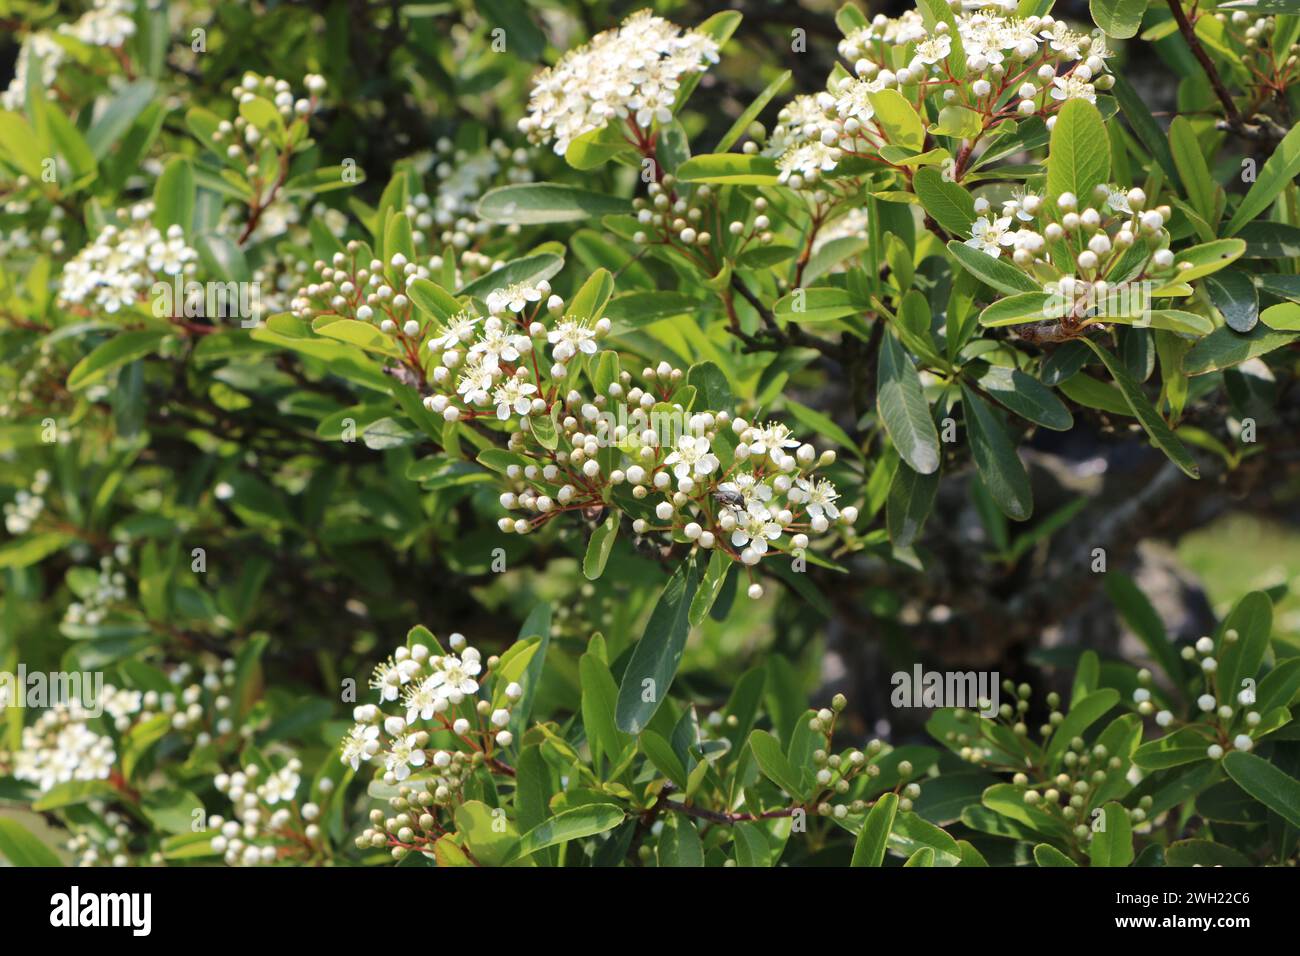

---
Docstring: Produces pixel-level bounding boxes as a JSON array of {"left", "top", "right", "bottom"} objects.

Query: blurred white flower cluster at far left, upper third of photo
[{"left": 59, "top": 202, "right": 199, "bottom": 315}]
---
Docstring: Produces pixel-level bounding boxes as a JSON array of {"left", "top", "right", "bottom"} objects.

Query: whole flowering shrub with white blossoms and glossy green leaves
[{"left": 0, "top": 0, "right": 1300, "bottom": 866}]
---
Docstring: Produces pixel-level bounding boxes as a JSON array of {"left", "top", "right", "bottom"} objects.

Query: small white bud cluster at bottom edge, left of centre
[{"left": 207, "top": 757, "right": 333, "bottom": 866}]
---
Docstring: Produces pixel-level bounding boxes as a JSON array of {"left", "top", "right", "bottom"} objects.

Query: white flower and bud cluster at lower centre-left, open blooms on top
[{"left": 339, "top": 633, "right": 524, "bottom": 860}]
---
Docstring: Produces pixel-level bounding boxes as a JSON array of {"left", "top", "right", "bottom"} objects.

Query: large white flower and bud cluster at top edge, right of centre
[{"left": 766, "top": 6, "right": 1114, "bottom": 189}]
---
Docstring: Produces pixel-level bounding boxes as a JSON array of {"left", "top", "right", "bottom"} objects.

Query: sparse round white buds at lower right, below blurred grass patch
[{"left": 1134, "top": 628, "right": 1262, "bottom": 760}]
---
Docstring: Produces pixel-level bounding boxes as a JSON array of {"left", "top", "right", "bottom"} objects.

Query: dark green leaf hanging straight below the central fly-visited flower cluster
[{"left": 615, "top": 555, "right": 699, "bottom": 734}]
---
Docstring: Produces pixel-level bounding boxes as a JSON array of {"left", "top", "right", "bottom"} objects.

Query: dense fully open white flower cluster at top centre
[{"left": 519, "top": 10, "right": 718, "bottom": 155}]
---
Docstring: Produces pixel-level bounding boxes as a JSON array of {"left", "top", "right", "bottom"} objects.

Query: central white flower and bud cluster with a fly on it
[{"left": 498, "top": 363, "right": 858, "bottom": 598}]
